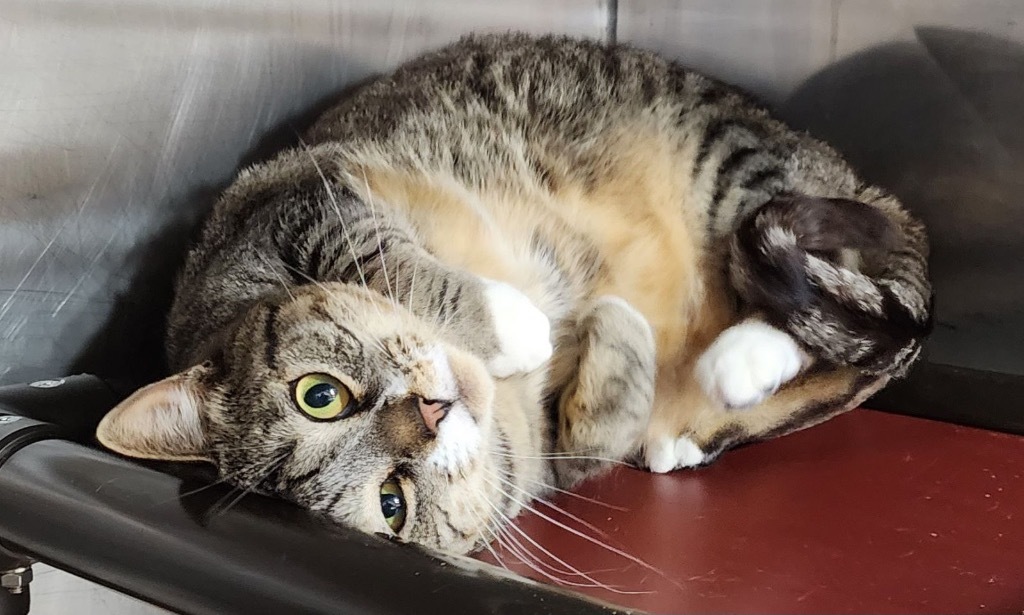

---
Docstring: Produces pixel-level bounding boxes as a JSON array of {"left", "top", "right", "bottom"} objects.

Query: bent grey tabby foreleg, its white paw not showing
[{"left": 554, "top": 296, "right": 655, "bottom": 488}]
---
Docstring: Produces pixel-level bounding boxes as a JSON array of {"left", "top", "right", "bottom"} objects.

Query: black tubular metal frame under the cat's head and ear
[{"left": 0, "top": 377, "right": 628, "bottom": 615}]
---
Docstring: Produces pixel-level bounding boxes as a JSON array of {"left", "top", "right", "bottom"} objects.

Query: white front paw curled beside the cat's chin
[{"left": 483, "top": 279, "right": 554, "bottom": 378}]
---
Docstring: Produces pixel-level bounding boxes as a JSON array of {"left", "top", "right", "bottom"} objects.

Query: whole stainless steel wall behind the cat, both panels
[{"left": 0, "top": 0, "right": 1024, "bottom": 388}]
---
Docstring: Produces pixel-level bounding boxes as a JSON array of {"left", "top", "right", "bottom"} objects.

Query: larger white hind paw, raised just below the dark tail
[{"left": 696, "top": 320, "right": 803, "bottom": 408}]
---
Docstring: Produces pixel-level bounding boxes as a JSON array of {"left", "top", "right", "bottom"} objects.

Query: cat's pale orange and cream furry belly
[{"left": 356, "top": 128, "right": 726, "bottom": 362}]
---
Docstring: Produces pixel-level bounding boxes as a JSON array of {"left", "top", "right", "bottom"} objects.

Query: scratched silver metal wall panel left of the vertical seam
[{"left": 0, "top": 0, "right": 608, "bottom": 382}]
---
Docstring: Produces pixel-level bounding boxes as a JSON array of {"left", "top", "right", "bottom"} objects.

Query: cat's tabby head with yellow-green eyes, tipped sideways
[{"left": 97, "top": 284, "right": 510, "bottom": 553}]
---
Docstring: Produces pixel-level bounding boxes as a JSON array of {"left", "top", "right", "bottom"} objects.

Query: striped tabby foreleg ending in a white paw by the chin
[{"left": 288, "top": 193, "right": 553, "bottom": 378}]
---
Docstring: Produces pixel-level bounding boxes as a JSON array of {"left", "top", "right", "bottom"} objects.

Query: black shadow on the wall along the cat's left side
[{"left": 72, "top": 78, "right": 382, "bottom": 388}]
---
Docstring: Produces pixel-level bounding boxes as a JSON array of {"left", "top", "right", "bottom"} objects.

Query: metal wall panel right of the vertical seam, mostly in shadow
[{"left": 617, "top": 0, "right": 1024, "bottom": 375}]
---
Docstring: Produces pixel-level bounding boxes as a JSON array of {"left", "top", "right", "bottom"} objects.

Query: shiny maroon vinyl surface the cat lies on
[{"left": 484, "top": 410, "right": 1024, "bottom": 613}]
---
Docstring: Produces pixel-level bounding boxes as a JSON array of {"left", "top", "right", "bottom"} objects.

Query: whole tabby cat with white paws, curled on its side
[{"left": 96, "top": 34, "right": 932, "bottom": 554}]
